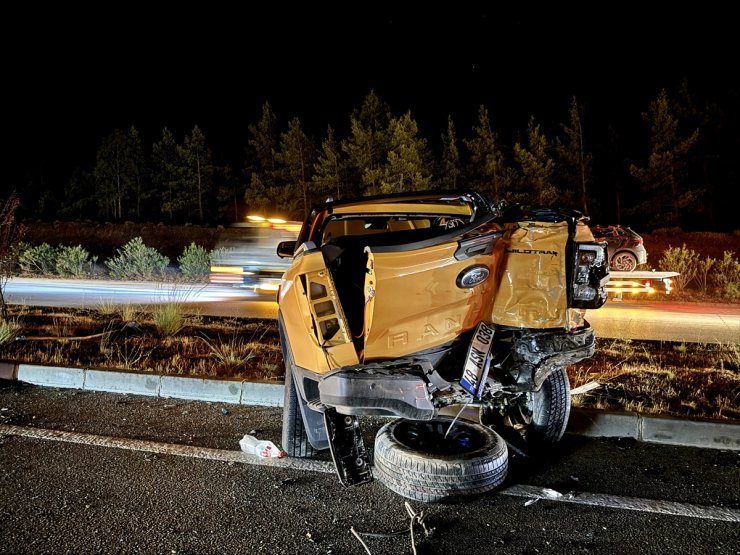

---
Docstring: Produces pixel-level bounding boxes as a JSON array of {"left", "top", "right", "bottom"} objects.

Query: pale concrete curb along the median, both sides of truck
[{"left": 0, "top": 363, "right": 740, "bottom": 451}]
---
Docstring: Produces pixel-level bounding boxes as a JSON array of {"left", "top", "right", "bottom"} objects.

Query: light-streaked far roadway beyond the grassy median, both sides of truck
[{"left": 6, "top": 278, "right": 740, "bottom": 343}]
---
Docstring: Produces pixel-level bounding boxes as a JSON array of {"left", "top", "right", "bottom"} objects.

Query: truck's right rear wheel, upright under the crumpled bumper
[{"left": 508, "top": 367, "right": 571, "bottom": 447}]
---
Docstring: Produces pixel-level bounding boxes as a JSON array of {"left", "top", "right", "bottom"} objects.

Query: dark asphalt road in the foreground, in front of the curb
[{"left": 0, "top": 382, "right": 740, "bottom": 555}]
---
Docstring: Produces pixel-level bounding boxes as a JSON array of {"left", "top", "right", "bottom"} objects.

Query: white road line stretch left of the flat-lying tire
[{"left": 0, "top": 424, "right": 335, "bottom": 474}]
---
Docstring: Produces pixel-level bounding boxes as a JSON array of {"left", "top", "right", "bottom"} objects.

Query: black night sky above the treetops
[{"left": 2, "top": 2, "right": 737, "bottom": 200}]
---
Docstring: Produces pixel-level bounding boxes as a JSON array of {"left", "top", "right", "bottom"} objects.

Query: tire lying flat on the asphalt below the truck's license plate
[{"left": 373, "top": 417, "right": 509, "bottom": 503}]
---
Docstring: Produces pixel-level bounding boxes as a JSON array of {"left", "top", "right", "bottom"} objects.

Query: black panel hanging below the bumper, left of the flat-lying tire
[{"left": 324, "top": 408, "right": 373, "bottom": 486}]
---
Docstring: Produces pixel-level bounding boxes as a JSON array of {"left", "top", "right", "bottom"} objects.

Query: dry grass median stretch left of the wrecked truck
[{"left": 0, "top": 305, "right": 283, "bottom": 379}]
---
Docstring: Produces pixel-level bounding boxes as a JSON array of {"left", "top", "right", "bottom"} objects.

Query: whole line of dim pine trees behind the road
[{"left": 46, "top": 83, "right": 737, "bottom": 231}]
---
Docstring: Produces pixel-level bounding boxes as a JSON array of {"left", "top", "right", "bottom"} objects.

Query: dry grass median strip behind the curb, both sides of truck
[{"left": 0, "top": 303, "right": 740, "bottom": 423}]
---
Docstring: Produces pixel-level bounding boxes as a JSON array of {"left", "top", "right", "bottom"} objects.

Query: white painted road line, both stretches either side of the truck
[{"left": 0, "top": 424, "right": 740, "bottom": 522}]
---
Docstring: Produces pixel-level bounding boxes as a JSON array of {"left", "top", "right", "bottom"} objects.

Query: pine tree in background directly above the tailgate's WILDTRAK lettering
[{"left": 514, "top": 116, "right": 560, "bottom": 205}]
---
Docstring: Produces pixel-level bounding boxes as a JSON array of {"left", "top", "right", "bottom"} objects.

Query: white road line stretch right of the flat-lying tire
[{"left": 499, "top": 484, "right": 740, "bottom": 522}]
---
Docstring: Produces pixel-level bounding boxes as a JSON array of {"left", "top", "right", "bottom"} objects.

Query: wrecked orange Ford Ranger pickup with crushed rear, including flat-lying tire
[{"left": 277, "top": 190, "right": 609, "bottom": 502}]
